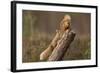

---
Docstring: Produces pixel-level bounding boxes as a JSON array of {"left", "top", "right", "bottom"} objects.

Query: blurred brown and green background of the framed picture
[{"left": 22, "top": 10, "right": 91, "bottom": 63}]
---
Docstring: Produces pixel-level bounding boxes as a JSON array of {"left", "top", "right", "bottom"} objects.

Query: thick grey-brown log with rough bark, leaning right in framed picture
[{"left": 48, "top": 31, "right": 75, "bottom": 61}]
